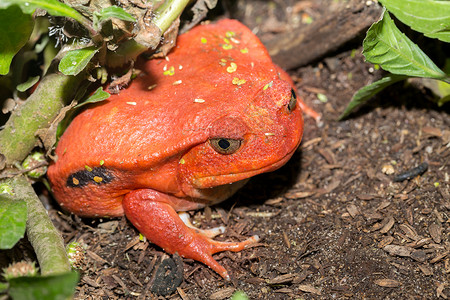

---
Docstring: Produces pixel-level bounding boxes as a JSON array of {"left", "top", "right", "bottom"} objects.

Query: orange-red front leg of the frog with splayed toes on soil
[{"left": 122, "top": 189, "right": 259, "bottom": 279}]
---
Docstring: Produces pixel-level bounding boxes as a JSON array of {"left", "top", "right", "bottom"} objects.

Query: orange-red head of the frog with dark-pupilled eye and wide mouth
[{"left": 179, "top": 80, "right": 303, "bottom": 201}]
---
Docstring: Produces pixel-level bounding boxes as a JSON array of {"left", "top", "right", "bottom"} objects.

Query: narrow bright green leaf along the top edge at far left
[{"left": 0, "top": 0, "right": 89, "bottom": 24}]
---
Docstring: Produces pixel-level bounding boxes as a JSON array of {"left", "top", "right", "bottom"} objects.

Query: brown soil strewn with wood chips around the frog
[{"left": 4, "top": 1, "right": 450, "bottom": 299}]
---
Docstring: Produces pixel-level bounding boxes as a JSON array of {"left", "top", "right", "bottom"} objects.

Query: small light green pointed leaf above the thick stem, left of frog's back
[{"left": 58, "top": 46, "right": 98, "bottom": 75}]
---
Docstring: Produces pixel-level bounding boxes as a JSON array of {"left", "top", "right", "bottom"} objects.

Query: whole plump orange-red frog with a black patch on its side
[{"left": 48, "top": 20, "right": 310, "bottom": 278}]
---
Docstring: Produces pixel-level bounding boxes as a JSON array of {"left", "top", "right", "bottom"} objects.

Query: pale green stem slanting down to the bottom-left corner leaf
[{"left": 0, "top": 175, "right": 71, "bottom": 276}]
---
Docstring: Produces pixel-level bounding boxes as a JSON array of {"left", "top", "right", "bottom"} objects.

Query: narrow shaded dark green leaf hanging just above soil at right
[{"left": 339, "top": 74, "right": 408, "bottom": 120}]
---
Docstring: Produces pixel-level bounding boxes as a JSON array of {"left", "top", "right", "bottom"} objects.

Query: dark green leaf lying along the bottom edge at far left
[{"left": 9, "top": 272, "right": 78, "bottom": 300}]
